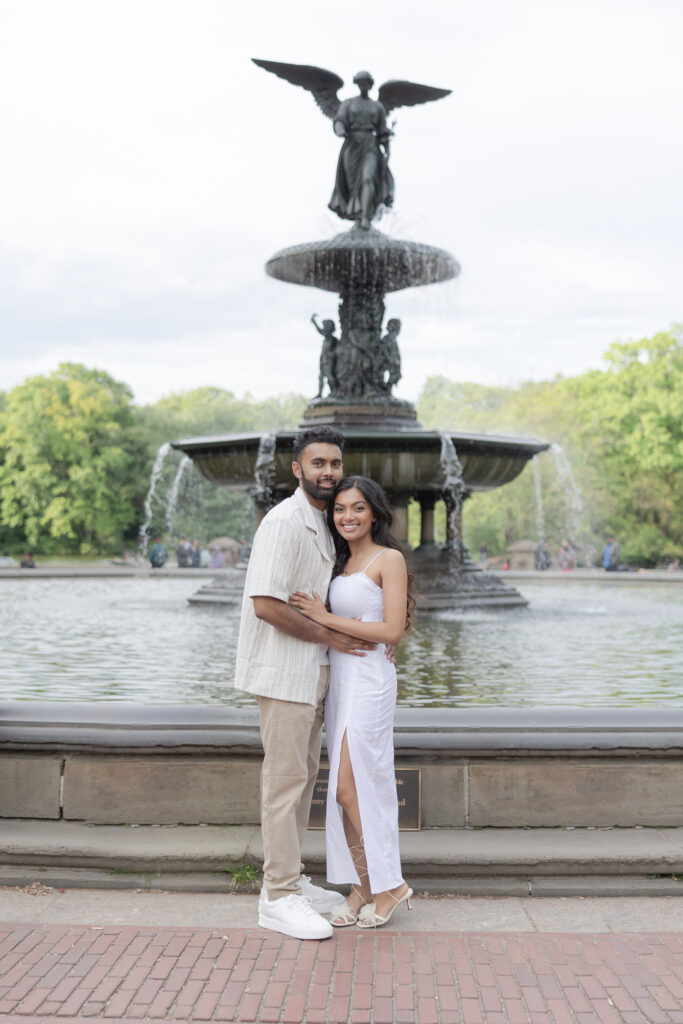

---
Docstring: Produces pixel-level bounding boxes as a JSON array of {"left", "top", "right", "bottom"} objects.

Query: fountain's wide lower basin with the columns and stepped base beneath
[{"left": 173, "top": 430, "right": 548, "bottom": 611}]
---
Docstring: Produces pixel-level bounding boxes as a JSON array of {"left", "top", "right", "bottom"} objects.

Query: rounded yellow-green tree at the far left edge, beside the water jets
[{"left": 0, "top": 362, "right": 139, "bottom": 553}]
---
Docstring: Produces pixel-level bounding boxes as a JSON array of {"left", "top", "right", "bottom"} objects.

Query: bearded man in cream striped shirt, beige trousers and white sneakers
[{"left": 234, "top": 427, "right": 376, "bottom": 939}]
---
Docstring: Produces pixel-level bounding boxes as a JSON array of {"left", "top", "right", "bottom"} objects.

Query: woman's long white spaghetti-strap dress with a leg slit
[{"left": 325, "top": 551, "right": 403, "bottom": 893}]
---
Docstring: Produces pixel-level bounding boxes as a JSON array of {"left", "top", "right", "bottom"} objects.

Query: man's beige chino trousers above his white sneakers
[{"left": 256, "top": 665, "right": 330, "bottom": 899}]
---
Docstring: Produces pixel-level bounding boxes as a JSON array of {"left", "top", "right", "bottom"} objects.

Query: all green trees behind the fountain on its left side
[{"left": 0, "top": 364, "right": 305, "bottom": 554}]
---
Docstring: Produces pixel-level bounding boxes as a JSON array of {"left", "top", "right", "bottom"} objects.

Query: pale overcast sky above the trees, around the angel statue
[{"left": 0, "top": 0, "right": 683, "bottom": 402}]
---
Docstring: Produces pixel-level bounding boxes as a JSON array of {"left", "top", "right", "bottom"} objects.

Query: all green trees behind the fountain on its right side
[{"left": 419, "top": 327, "right": 683, "bottom": 565}]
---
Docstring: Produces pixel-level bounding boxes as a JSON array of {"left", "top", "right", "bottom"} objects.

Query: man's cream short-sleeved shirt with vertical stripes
[{"left": 232, "top": 487, "right": 334, "bottom": 705}]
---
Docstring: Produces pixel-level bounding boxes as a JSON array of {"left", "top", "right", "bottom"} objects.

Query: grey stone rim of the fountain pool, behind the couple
[{"left": 0, "top": 700, "right": 683, "bottom": 758}]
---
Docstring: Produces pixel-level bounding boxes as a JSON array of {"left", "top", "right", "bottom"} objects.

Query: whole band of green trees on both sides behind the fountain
[{"left": 0, "top": 326, "right": 683, "bottom": 565}]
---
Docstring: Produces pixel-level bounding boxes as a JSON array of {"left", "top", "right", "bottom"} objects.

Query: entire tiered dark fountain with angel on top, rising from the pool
[{"left": 173, "top": 60, "right": 548, "bottom": 610}]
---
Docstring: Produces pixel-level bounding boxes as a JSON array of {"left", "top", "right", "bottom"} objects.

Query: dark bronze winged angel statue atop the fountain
[{"left": 252, "top": 57, "right": 451, "bottom": 230}]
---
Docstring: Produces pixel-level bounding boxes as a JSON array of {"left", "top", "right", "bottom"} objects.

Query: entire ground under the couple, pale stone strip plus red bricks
[{"left": 0, "top": 884, "right": 683, "bottom": 1024}]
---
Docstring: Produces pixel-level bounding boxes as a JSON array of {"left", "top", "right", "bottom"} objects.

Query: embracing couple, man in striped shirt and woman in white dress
[{"left": 234, "top": 426, "right": 414, "bottom": 939}]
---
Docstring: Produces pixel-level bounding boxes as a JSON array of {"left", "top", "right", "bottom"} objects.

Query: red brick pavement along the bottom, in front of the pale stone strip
[{"left": 0, "top": 925, "right": 683, "bottom": 1024}]
